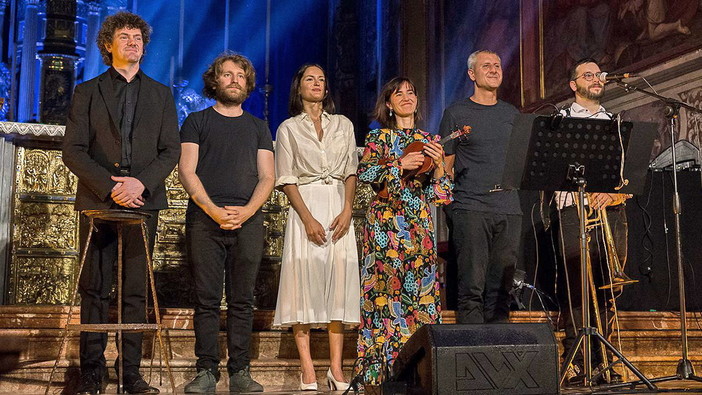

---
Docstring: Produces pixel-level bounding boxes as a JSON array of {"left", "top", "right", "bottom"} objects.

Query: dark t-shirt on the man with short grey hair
[{"left": 439, "top": 99, "right": 522, "bottom": 214}]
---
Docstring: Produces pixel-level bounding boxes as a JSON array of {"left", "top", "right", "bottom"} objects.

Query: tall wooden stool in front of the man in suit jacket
[{"left": 45, "top": 209, "right": 175, "bottom": 395}]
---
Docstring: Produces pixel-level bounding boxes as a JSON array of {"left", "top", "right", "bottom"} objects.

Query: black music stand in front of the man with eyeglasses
[{"left": 502, "top": 114, "right": 657, "bottom": 391}]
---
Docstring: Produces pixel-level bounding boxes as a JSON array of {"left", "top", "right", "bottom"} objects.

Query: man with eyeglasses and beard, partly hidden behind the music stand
[{"left": 551, "top": 58, "right": 628, "bottom": 385}]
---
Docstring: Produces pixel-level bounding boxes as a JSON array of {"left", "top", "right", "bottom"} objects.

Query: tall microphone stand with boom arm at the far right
[{"left": 607, "top": 80, "right": 702, "bottom": 388}]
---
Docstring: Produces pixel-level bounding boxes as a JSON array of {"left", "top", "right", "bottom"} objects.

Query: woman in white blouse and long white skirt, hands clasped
[{"left": 273, "top": 64, "right": 360, "bottom": 391}]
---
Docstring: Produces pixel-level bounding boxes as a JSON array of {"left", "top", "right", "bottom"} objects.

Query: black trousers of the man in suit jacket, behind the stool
[{"left": 78, "top": 207, "right": 158, "bottom": 375}]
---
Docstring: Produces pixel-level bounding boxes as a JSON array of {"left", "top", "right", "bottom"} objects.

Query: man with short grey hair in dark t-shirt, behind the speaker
[{"left": 440, "top": 50, "right": 522, "bottom": 324}]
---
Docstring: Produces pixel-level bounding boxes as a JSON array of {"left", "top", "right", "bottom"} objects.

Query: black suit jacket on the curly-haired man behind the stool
[{"left": 63, "top": 71, "right": 180, "bottom": 210}]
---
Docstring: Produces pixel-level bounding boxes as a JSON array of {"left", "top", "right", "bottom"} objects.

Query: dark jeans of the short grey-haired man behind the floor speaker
[{"left": 451, "top": 209, "right": 522, "bottom": 324}]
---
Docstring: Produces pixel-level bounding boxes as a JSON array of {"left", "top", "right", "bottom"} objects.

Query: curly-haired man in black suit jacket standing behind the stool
[{"left": 63, "top": 12, "right": 180, "bottom": 394}]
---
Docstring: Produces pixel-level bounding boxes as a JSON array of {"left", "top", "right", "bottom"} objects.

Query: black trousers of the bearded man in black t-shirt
[{"left": 185, "top": 209, "right": 265, "bottom": 377}]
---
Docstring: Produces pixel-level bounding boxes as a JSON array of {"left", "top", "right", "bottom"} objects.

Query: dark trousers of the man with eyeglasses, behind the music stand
[{"left": 552, "top": 205, "right": 627, "bottom": 363}]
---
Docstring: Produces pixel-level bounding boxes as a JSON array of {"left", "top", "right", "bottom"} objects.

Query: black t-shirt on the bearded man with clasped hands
[{"left": 180, "top": 107, "right": 273, "bottom": 210}]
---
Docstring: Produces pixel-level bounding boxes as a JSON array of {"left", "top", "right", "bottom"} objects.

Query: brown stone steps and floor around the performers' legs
[{"left": 0, "top": 306, "right": 702, "bottom": 394}]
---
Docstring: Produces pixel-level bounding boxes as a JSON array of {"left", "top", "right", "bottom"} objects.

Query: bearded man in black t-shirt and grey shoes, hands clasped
[{"left": 178, "top": 53, "right": 275, "bottom": 393}]
